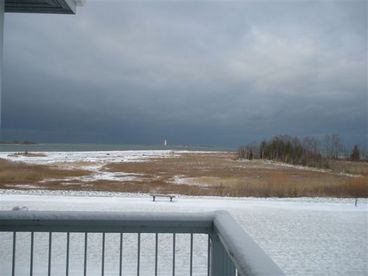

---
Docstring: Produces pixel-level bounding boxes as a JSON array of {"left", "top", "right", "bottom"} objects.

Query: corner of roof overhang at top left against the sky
[{"left": 5, "top": 0, "right": 85, "bottom": 14}]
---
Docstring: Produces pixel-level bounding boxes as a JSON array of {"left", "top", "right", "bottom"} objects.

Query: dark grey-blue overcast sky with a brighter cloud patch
[{"left": 2, "top": 0, "right": 368, "bottom": 146}]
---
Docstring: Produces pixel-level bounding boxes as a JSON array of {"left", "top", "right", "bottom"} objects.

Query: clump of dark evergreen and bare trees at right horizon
[{"left": 237, "top": 134, "right": 367, "bottom": 168}]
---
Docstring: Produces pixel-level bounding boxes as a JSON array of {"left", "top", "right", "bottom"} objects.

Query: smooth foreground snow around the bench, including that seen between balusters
[{"left": 0, "top": 190, "right": 368, "bottom": 275}]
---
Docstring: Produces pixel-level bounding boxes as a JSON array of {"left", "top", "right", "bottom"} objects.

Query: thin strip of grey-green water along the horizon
[{"left": 0, "top": 144, "right": 234, "bottom": 152}]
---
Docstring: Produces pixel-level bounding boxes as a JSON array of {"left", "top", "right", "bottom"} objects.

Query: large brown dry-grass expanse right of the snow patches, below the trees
[{"left": 107, "top": 154, "right": 368, "bottom": 197}]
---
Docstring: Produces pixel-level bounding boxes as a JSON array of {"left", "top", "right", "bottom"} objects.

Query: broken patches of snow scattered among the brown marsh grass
[{"left": 0, "top": 150, "right": 360, "bottom": 189}]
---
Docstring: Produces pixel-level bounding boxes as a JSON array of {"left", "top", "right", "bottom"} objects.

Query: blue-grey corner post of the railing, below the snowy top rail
[{"left": 210, "top": 232, "right": 235, "bottom": 276}]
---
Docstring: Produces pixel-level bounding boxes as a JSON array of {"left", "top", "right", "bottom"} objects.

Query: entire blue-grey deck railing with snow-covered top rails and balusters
[{"left": 0, "top": 211, "right": 283, "bottom": 276}]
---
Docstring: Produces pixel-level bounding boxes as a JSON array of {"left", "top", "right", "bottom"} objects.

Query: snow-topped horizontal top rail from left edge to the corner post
[{"left": 0, "top": 211, "right": 214, "bottom": 233}]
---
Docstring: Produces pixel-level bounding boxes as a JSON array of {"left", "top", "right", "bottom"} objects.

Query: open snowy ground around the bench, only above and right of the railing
[{"left": 0, "top": 190, "right": 368, "bottom": 275}]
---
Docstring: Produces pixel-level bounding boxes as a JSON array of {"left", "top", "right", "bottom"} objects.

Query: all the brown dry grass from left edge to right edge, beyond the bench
[{"left": 0, "top": 153, "right": 368, "bottom": 197}]
